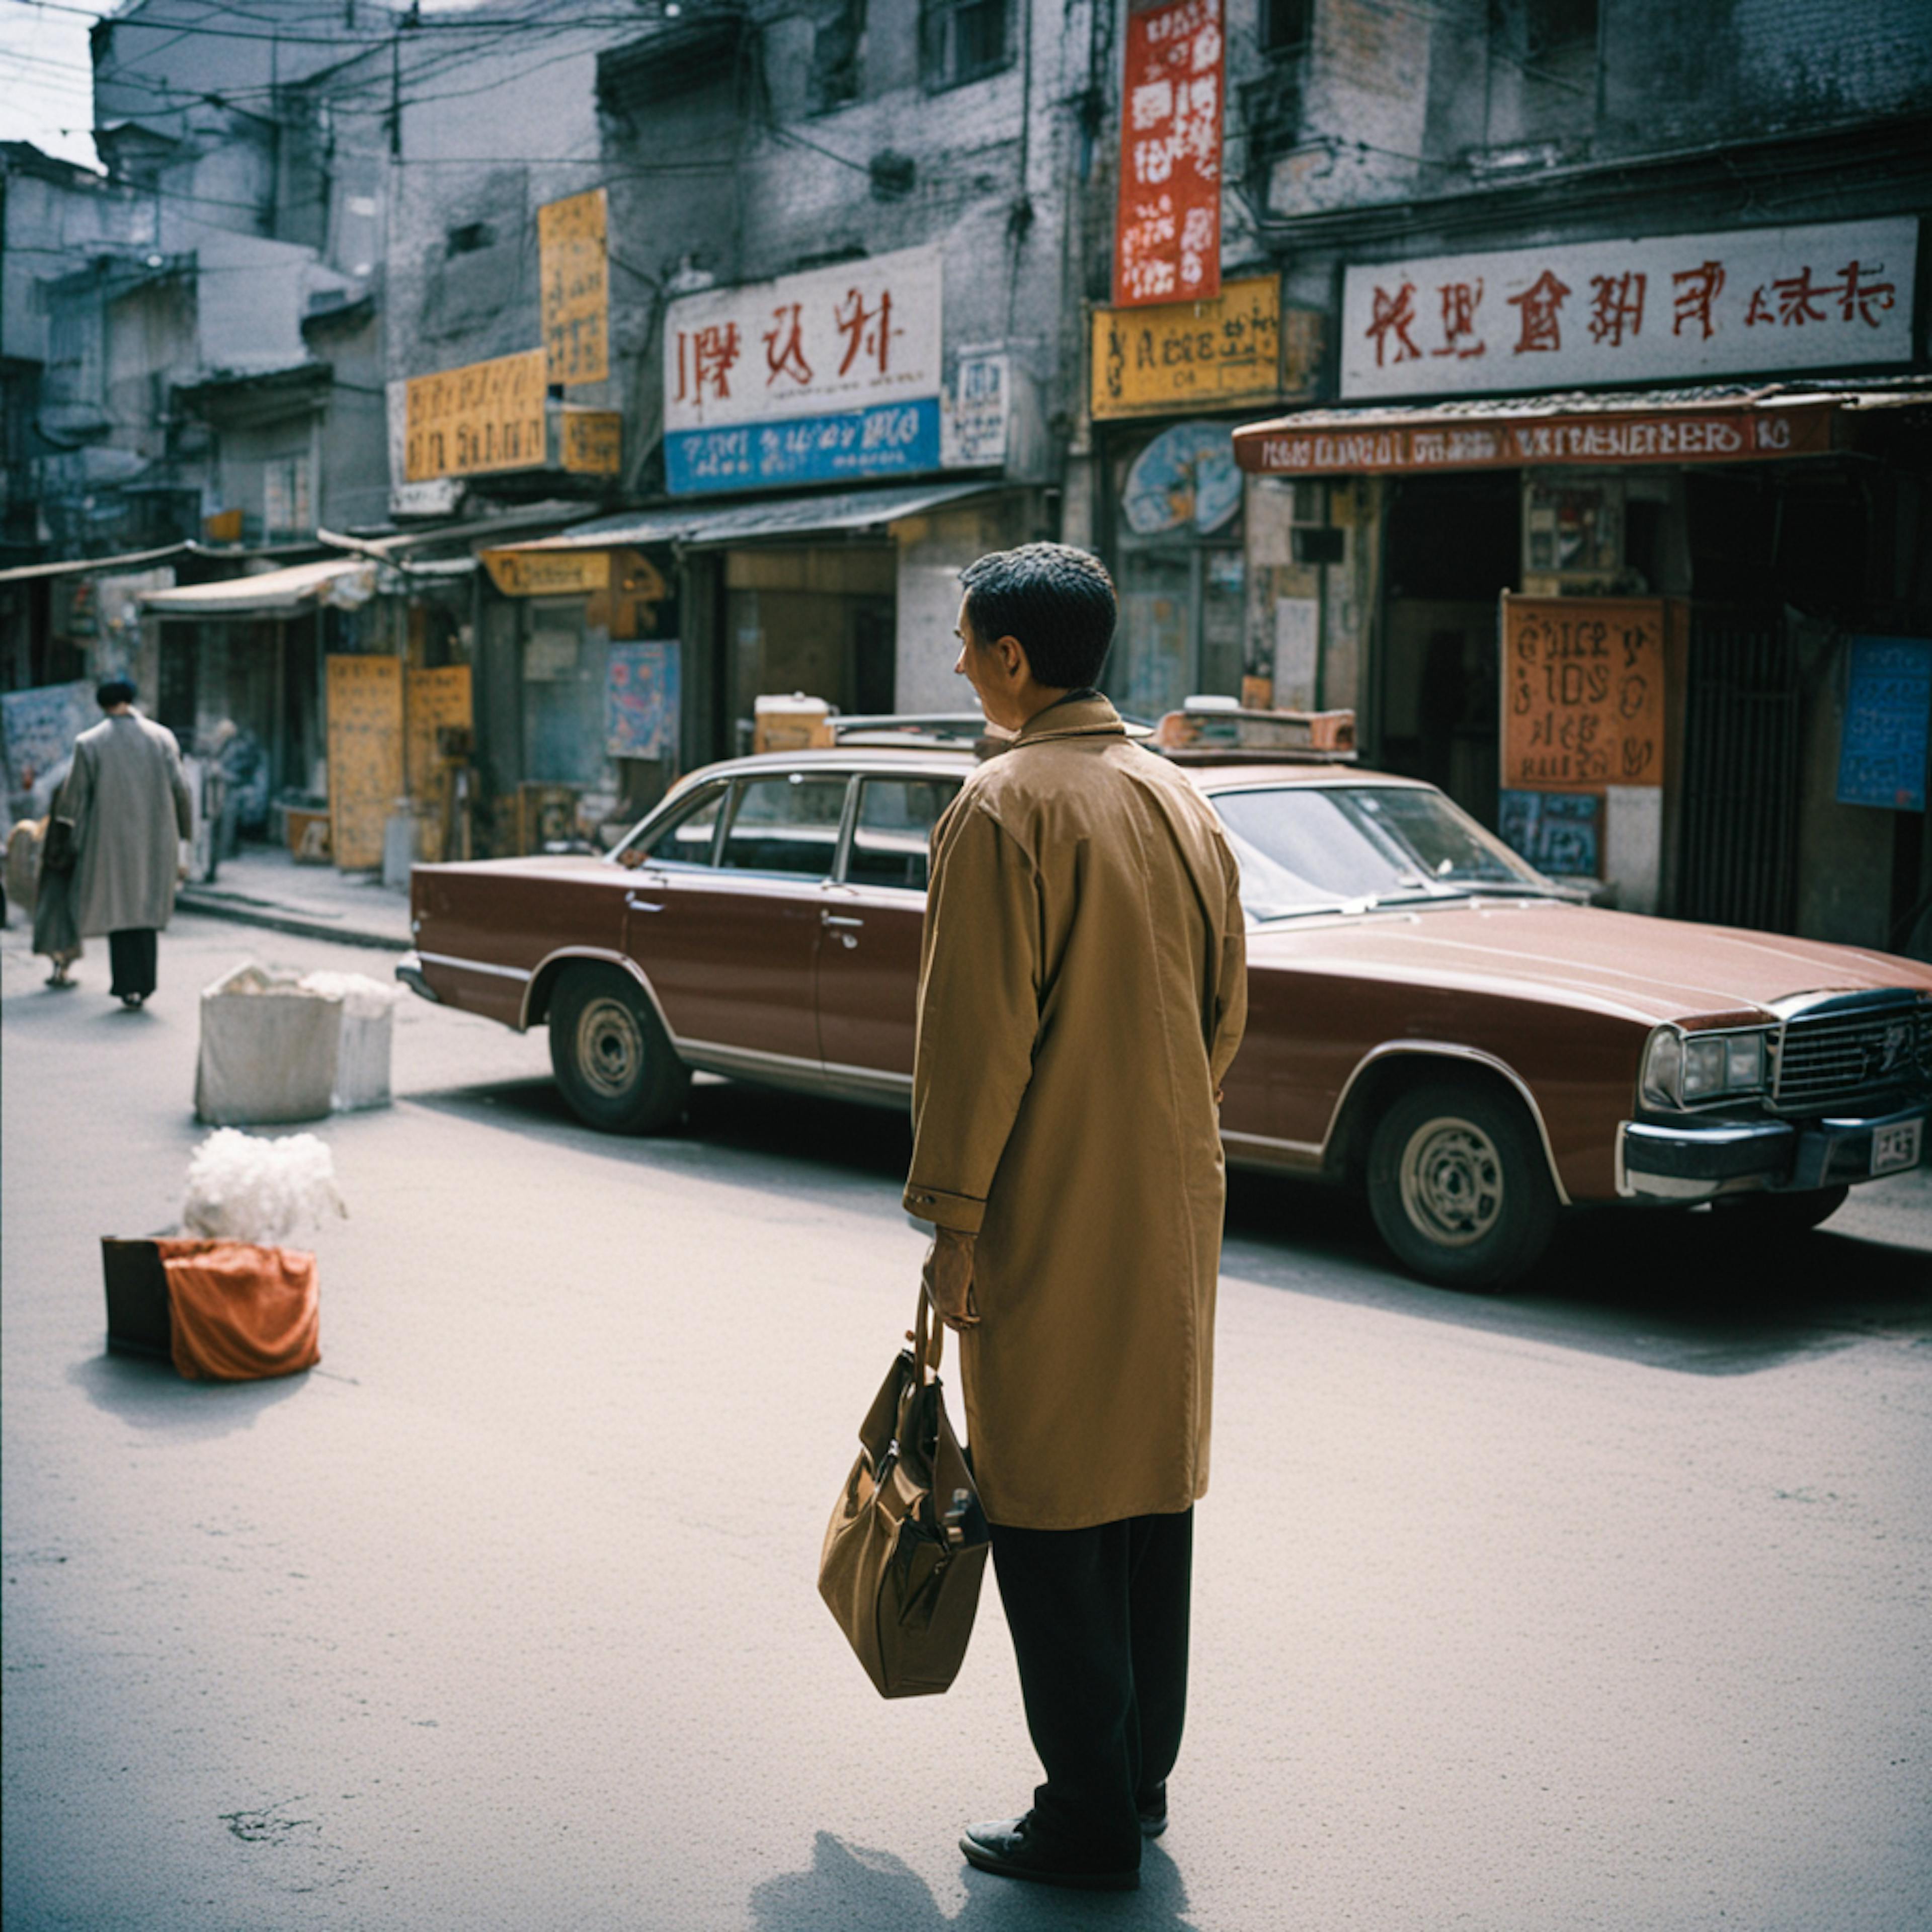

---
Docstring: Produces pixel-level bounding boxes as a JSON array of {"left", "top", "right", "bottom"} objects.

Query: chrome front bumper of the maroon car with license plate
[{"left": 1617, "top": 1099, "right": 1932, "bottom": 1201}]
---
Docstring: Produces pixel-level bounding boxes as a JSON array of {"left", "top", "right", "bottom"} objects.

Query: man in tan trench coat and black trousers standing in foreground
[{"left": 906, "top": 543, "right": 1246, "bottom": 1890}]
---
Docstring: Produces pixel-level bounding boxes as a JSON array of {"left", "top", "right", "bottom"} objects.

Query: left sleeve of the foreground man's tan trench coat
[{"left": 904, "top": 800, "right": 1039, "bottom": 1235}]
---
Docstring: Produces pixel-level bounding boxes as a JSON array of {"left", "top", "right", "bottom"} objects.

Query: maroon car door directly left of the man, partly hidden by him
[{"left": 819, "top": 773, "right": 958, "bottom": 1097}]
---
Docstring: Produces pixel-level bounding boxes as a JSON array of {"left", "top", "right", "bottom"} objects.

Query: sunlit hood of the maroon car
[{"left": 1248, "top": 899, "right": 1932, "bottom": 1026}]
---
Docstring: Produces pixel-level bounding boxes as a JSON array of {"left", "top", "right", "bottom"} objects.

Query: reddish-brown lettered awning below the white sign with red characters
[{"left": 1235, "top": 384, "right": 1932, "bottom": 475}]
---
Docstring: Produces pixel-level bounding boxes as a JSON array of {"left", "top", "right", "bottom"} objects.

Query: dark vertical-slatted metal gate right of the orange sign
[{"left": 1677, "top": 609, "right": 1801, "bottom": 933}]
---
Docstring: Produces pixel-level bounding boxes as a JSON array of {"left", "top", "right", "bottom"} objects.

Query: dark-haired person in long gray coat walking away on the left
[{"left": 54, "top": 678, "right": 195, "bottom": 1007}]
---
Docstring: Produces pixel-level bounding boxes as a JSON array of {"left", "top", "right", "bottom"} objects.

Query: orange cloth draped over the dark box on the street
[{"left": 154, "top": 1240, "right": 323, "bottom": 1382}]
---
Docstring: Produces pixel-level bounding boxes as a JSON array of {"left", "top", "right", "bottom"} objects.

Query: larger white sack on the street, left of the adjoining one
[{"left": 195, "top": 962, "right": 342, "bottom": 1126}]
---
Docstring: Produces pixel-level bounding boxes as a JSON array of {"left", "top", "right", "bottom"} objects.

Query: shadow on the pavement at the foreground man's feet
[{"left": 750, "top": 1831, "right": 1190, "bottom": 1932}]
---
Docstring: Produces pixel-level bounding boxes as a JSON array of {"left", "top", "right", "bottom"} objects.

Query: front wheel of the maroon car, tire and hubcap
[{"left": 1368, "top": 1080, "right": 1557, "bottom": 1289}]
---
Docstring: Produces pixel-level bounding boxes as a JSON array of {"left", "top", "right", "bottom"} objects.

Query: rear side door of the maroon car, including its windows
[{"left": 628, "top": 771, "right": 850, "bottom": 1084}]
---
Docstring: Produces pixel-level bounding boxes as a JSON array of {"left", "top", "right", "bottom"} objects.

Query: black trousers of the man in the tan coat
[{"left": 993, "top": 1509, "right": 1194, "bottom": 1870}]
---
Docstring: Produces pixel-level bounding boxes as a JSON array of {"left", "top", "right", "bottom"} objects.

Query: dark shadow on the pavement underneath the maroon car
[{"left": 402, "top": 1078, "right": 1932, "bottom": 1376}]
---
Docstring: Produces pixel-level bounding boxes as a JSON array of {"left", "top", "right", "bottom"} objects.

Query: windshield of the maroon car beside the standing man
[{"left": 1214, "top": 784, "right": 1553, "bottom": 920}]
